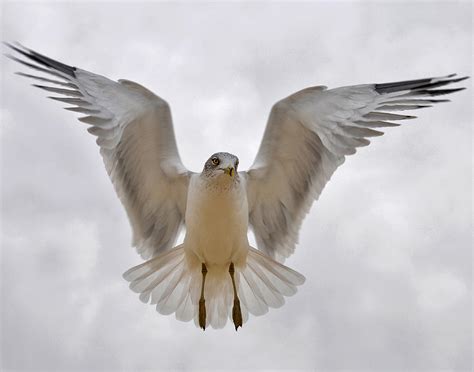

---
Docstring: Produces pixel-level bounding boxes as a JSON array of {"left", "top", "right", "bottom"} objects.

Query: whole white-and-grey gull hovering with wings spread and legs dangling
[{"left": 5, "top": 43, "right": 468, "bottom": 330}]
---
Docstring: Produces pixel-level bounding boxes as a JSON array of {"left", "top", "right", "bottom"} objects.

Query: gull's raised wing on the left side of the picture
[{"left": 7, "top": 44, "right": 190, "bottom": 259}]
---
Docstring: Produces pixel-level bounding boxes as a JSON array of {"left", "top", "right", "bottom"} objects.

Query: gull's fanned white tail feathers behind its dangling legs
[{"left": 123, "top": 245, "right": 304, "bottom": 328}]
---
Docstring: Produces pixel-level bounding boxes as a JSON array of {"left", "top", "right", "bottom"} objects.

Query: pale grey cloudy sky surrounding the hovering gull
[{"left": 1, "top": 2, "right": 473, "bottom": 371}]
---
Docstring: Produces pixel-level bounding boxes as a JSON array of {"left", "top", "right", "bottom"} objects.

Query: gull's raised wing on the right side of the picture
[{"left": 247, "top": 75, "right": 467, "bottom": 260}]
